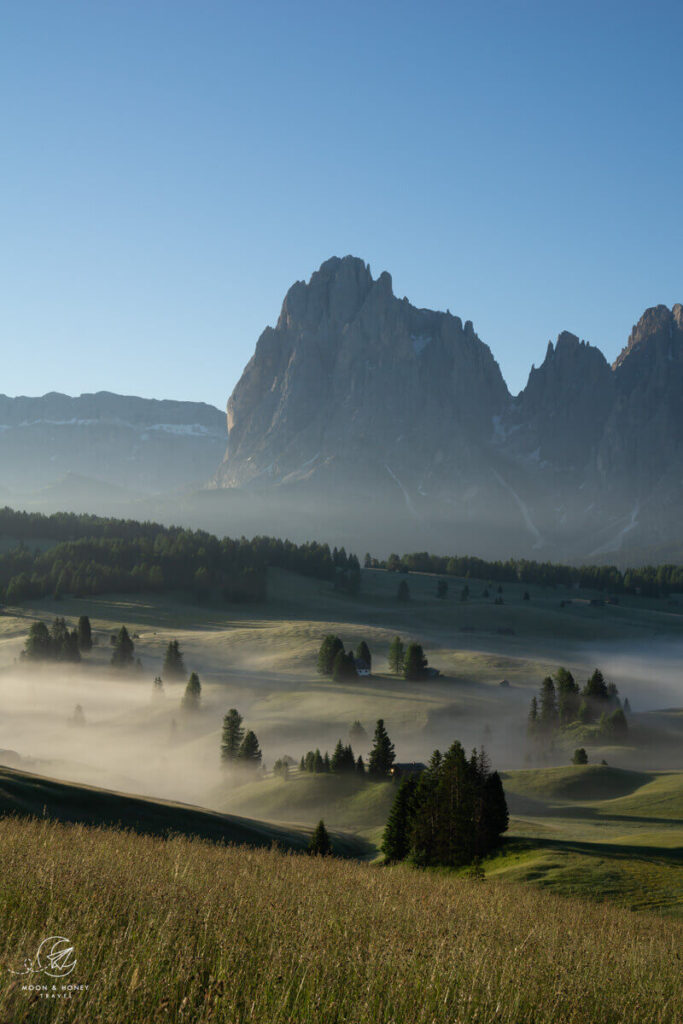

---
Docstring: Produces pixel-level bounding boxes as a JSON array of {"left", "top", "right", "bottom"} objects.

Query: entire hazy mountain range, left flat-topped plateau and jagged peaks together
[{"left": 0, "top": 256, "right": 683, "bottom": 565}]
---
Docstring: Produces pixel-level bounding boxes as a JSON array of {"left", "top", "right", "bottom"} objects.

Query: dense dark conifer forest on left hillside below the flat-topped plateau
[{"left": 0, "top": 508, "right": 359, "bottom": 604}]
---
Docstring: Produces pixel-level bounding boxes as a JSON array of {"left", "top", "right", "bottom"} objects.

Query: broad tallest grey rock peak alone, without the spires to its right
[{"left": 218, "top": 256, "right": 509, "bottom": 487}]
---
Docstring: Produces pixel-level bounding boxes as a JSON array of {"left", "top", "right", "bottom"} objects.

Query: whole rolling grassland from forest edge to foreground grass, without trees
[{"left": 0, "top": 570, "right": 683, "bottom": 1024}]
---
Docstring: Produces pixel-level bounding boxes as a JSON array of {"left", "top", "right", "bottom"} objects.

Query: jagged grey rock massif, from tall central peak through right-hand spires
[{"left": 214, "top": 256, "right": 683, "bottom": 558}]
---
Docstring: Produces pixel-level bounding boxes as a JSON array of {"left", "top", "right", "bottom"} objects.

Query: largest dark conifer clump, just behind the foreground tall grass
[{"left": 382, "top": 742, "right": 509, "bottom": 867}]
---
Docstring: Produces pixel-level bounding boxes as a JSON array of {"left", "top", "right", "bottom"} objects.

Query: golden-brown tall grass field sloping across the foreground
[{"left": 0, "top": 818, "right": 683, "bottom": 1024}]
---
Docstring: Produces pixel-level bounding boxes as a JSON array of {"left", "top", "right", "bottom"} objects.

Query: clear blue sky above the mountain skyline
[{"left": 0, "top": 0, "right": 683, "bottom": 408}]
